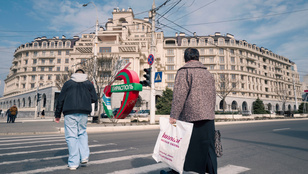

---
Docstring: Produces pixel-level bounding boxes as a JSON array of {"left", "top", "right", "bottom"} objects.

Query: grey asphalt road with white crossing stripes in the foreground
[{"left": 0, "top": 119, "right": 308, "bottom": 174}]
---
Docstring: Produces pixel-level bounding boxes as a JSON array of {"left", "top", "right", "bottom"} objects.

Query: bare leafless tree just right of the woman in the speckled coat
[{"left": 216, "top": 74, "right": 240, "bottom": 112}]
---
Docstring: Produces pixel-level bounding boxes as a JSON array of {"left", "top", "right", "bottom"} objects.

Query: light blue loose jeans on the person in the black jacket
[{"left": 64, "top": 114, "right": 90, "bottom": 167}]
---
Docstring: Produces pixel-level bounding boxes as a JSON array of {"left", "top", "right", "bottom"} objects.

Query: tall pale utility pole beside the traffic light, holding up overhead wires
[{"left": 150, "top": 0, "right": 156, "bottom": 124}]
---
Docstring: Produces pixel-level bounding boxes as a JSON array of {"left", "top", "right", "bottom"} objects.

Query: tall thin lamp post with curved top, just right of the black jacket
[{"left": 82, "top": 1, "right": 98, "bottom": 116}]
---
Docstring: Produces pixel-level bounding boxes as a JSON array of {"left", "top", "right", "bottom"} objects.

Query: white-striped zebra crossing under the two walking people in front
[{"left": 0, "top": 134, "right": 249, "bottom": 174}]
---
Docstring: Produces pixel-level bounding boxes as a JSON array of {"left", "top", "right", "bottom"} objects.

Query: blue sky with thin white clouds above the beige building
[{"left": 0, "top": 0, "right": 308, "bottom": 95}]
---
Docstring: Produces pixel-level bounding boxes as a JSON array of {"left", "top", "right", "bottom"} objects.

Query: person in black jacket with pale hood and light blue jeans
[{"left": 55, "top": 69, "right": 97, "bottom": 170}]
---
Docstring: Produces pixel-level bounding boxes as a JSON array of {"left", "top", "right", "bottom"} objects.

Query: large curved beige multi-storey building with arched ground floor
[{"left": 0, "top": 8, "right": 302, "bottom": 116}]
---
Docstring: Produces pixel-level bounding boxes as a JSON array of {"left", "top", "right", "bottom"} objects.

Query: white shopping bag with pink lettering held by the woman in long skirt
[{"left": 152, "top": 117, "right": 193, "bottom": 173}]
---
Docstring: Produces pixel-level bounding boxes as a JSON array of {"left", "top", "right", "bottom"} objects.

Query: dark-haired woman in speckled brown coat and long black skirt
[{"left": 160, "top": 48, "right": 217, "bottom": 174}]
